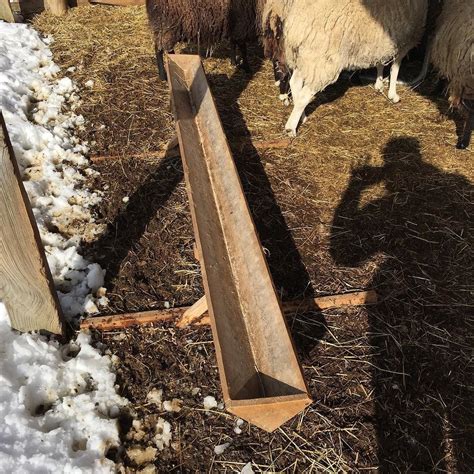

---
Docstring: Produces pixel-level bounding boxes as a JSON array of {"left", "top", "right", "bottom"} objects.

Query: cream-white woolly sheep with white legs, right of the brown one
[{"left": 262, "top": 0, "right": 430, "bottom": 136}]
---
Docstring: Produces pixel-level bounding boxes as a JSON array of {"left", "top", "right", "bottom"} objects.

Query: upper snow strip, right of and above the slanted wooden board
[{"left": 0, "top": 22, "right": 104, "bottom": 319}]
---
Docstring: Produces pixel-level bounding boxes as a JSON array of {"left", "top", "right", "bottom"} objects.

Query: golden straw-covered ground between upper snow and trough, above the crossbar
[{"left": 34, "top": 6, "right": 173, "bottom": 154}]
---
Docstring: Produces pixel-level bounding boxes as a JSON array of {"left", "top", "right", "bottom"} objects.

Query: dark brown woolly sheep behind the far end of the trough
[{"left": 146, "top": 0, "right": 257, "bottom": 78}]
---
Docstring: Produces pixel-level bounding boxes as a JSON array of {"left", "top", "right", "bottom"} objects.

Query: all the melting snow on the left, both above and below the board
[{"left": 0, "top": 22, "right": 126, "bottom": 473}]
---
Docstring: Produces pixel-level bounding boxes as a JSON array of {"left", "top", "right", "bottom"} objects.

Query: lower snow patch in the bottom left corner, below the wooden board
[{"left": 0, "top": 304, "right": 126, "bottom": 472}]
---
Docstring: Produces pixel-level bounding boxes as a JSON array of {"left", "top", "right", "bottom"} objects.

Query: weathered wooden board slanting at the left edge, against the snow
[{"left": 0, "top": 113, "right": 63, "bottom": 334}]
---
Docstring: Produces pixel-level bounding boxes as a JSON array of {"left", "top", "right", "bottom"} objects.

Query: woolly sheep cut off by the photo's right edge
[{"left": 431, "top": 0, "right": 474, "bottom": 148}]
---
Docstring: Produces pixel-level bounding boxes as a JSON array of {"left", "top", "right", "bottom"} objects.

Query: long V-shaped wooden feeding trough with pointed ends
[{"left": 167, "top": 55, "right": 311, "bottom": 431}]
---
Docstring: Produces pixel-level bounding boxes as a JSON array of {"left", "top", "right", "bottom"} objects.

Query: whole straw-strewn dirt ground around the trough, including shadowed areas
[{"left": 35, "top": 7, "right": 474, "bottom": 472}]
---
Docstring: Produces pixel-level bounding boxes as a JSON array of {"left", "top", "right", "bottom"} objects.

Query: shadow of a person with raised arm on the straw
[{"left": 331, "top": 137, "right": 474, "bottom": 472}]
